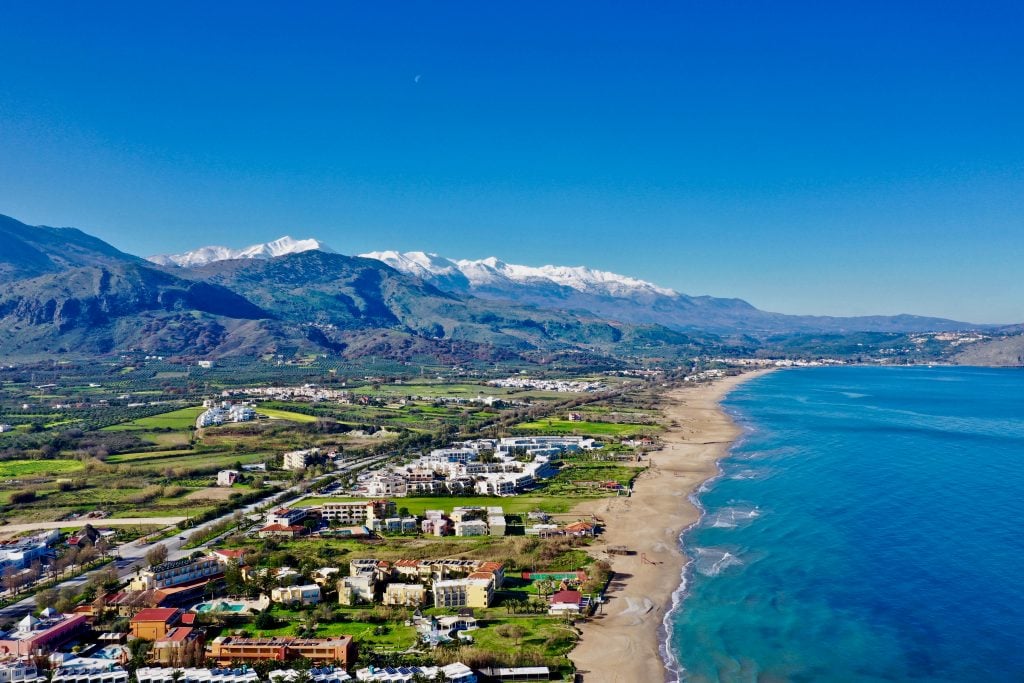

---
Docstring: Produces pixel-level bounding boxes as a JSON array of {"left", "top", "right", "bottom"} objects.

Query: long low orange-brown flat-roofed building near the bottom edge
[{"left": 208, "top": 636, "right": 355, "bottom": 668}]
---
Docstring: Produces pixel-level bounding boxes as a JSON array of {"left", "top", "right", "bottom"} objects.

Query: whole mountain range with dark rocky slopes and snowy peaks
[{"left": 0, "top": 216, "right": 1011, "bottom": 367}]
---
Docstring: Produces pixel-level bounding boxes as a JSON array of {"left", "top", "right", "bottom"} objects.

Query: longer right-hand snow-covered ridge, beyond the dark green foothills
[{"left": 360, "top": 251, "right": 679, "bottom": 297}]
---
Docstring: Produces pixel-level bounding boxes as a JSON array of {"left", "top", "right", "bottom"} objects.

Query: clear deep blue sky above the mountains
[{"left": 0, "top": 2, "right": 1024, "bottom": 322}]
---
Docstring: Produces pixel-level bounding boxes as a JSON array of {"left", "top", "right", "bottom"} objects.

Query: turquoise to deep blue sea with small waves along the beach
[{"left": 667, "top": 367, "right": 1024, "bottom": 683}]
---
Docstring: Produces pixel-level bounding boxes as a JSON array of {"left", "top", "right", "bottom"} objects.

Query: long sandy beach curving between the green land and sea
[{"left": 569, "top": 369, "right": 772, "bottom": 683}]
